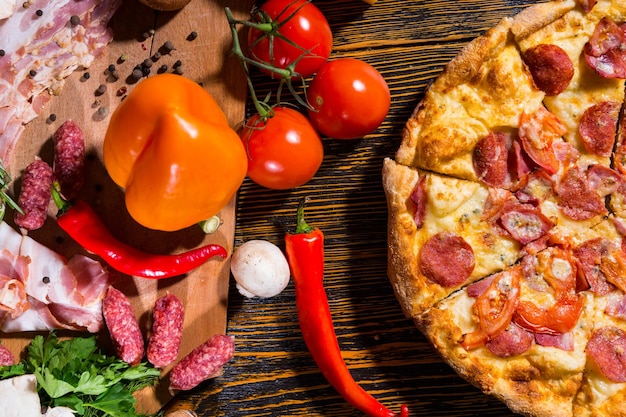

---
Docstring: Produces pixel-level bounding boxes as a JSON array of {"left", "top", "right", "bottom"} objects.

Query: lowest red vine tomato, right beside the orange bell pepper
[{"left": 241, "top": 107, "right": 324, "bottom": 190}]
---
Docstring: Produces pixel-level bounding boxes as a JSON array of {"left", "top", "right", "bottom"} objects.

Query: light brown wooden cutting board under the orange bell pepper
[{"left": 0, "top": 0, "right": 253, "bottom": 413}]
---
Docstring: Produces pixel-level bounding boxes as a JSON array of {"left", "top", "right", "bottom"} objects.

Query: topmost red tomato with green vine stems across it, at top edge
[{"left": 248, "top": 0, "right": 333, "bottom": 78}]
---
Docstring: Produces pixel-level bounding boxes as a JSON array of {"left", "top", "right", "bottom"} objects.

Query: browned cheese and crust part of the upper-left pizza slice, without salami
[{"left": 396, "top": 18, "right": 545, "bottom": 181}]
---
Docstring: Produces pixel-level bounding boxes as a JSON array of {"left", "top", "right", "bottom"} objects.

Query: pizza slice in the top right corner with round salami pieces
[{"left": 511, "top": 0, "right": 626, "bottom": 166}]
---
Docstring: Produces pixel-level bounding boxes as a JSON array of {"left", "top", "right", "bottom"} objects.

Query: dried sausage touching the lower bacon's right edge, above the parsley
[{"left": 102, "top": 287, "right": 144, "bottom": 365}]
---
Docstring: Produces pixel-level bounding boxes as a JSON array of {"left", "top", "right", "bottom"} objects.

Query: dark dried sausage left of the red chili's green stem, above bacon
[{"left": 15, "top": 158, "right": 54, "bottom": 230}]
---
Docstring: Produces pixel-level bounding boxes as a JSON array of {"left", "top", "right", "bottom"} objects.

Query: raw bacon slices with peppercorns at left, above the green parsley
[{"left": 0, "top": 222, "right": 110, "bottom": 333}]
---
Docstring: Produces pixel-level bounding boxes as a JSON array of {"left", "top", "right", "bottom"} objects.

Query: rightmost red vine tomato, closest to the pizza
[{"left": 306, "top": 58, "right": 391, "bottom": 139}]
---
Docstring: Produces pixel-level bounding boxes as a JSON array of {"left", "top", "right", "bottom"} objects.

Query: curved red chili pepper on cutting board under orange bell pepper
[{"left": 52, "top": 187, "right": 227, "bottom": 279}]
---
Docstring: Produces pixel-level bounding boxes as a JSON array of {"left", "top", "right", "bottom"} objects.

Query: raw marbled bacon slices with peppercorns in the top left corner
[{"left": 0, "top": 0, "right": 121, "bottom": 168}]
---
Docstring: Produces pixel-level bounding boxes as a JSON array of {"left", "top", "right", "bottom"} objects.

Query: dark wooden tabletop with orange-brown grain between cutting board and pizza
[{"left": 168, "top": 0, "right": 537, "bottom": 417}]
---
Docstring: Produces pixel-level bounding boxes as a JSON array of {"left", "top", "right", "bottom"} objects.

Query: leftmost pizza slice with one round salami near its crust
[{"left": 383, "top": 159, "right": 606, "bottom": 321}]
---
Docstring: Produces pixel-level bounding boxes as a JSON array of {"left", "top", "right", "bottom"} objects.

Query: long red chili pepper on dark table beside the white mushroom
[{"left": 285, "top": 200, "right": 409, "bottom": 417}]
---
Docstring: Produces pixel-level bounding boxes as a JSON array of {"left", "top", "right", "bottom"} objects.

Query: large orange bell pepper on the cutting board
[{"left": 103, "top": 74, "right": 248, "bottom": 231}]
